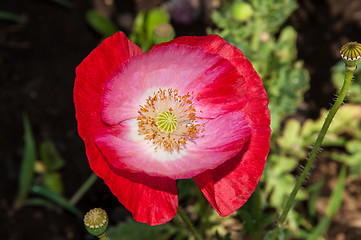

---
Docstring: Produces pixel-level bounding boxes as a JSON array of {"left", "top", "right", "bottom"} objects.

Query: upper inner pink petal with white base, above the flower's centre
[{"left": 101, "top": 44, "right": 242, "bottom": 125}]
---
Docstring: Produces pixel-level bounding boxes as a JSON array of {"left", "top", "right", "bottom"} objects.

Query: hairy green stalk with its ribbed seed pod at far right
[{"left": 271, "top": 42, "right": 361, "bottom": 240}]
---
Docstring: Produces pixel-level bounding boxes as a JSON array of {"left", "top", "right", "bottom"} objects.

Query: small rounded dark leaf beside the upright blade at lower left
[{"left": 39, "top": 140, "right": 65, "bottom": 171}]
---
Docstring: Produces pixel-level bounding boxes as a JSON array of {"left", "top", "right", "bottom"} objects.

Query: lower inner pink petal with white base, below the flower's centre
[{"left": 95, "top": 109, "right": 251, "bottom": 179}]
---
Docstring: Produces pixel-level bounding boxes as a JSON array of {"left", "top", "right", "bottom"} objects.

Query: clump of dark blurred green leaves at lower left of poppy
[{"left": 14, "top": 115, "right": 82, "bottom": 217}]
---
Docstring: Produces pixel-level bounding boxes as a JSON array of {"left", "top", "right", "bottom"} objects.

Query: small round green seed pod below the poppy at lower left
[{"left": 84, "top": 208, "right": 109, "bottom": 237}]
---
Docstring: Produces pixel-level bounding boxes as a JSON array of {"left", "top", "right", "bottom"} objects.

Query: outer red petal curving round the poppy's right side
[{"left": 156, "top": 35, "right": 271, "bottom": 216}]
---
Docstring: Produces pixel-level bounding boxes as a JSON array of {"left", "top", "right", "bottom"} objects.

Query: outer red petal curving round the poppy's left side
[{"left": 74, "top": 32, "right": 178, "bottom": 225}]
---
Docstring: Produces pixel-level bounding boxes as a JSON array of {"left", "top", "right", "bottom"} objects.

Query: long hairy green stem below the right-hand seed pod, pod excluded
[{"left": 271, "top": 66, "right": 356, "bottom": 240}]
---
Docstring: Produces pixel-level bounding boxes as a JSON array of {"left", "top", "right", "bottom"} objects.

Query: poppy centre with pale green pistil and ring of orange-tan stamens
[{"left": 137, "top": 88, "right": 204, "bottom": 152}]
